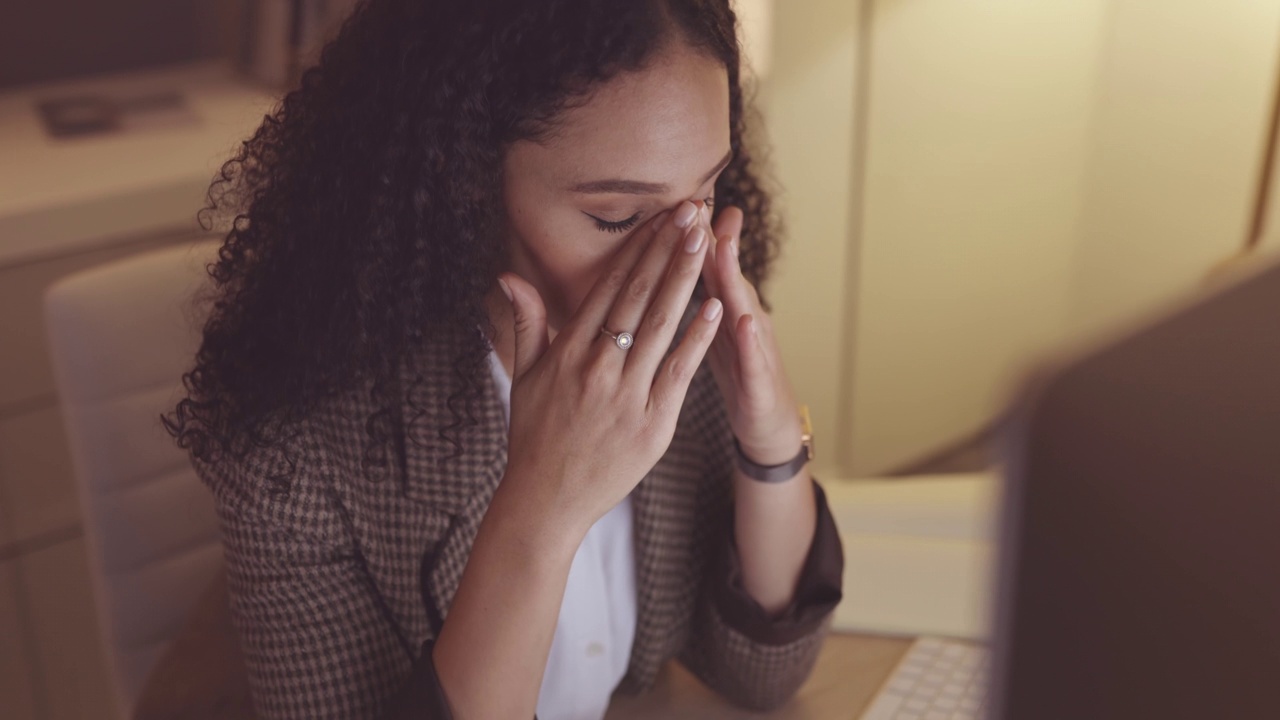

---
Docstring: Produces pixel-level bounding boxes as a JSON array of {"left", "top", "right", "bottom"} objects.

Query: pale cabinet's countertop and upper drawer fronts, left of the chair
[{"left": 0, "top": 63, "right": 271, "bottom": 548}]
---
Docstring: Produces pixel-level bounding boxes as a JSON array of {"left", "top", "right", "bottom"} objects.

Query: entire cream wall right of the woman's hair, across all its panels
[{"left": 763, "top": 0, "right": 1280, "bottom": 475}]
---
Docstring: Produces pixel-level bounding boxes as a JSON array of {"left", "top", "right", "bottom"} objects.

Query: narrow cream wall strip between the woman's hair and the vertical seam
[{"left": 759, "top": 0, "right": 860, "bottom": 477}]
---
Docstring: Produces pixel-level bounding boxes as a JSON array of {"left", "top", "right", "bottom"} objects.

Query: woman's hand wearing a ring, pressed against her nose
[{"left": 499, "top": 202, "right": 723, "bottom": 533}]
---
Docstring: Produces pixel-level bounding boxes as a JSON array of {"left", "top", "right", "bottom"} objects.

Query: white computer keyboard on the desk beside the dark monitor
[{"left": 861, "top": 637, "right": 987, "bottom": 720}]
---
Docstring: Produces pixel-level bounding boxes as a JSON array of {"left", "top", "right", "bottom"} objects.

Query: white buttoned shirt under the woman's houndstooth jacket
[{"left": 489, "top": 351, "right": 636, "bottom": 720}]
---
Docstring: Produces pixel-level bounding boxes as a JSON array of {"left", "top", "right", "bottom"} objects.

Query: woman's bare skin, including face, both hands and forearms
[{"left": 434, "top": 42, "right": 815, "bottom": 719}]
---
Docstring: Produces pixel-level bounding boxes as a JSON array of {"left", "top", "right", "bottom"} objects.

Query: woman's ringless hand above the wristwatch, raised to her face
[{"left": 699, "top": 202, "right": 803, "bottom": 465}]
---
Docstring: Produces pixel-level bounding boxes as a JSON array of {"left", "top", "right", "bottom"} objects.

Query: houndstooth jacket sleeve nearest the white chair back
[{"left": 197, "top": 443, "right": 449, "bottom": 720}]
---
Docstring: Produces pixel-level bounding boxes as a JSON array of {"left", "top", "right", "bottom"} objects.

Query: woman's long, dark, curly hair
[{"left": 161, "top": 0, "right": 778, "bottom": 481}]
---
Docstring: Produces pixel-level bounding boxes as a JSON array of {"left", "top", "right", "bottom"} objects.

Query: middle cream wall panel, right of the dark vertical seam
[{"left": 845, "top": 0, "right": 1105, "bottom": 475}]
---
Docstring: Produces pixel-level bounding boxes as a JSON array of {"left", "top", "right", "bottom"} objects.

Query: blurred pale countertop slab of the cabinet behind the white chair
[{"left": 0, "top": 60, "right": 276, "bottom": 266}]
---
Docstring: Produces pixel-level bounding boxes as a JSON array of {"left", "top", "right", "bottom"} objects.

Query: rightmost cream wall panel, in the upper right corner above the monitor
[{"left": 1070, "top": 0, "right": 1280, "bottom": 332}]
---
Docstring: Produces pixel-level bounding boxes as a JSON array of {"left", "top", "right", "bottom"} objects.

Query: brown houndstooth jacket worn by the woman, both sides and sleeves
[{"left": 195, "top": 316, "right": 844, "bottom": 719}]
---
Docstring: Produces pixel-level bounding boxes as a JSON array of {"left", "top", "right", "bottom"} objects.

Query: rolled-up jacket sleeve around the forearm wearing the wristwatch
[{"left": 680, "top": 474, "right": 844, "bottom": 710}]
